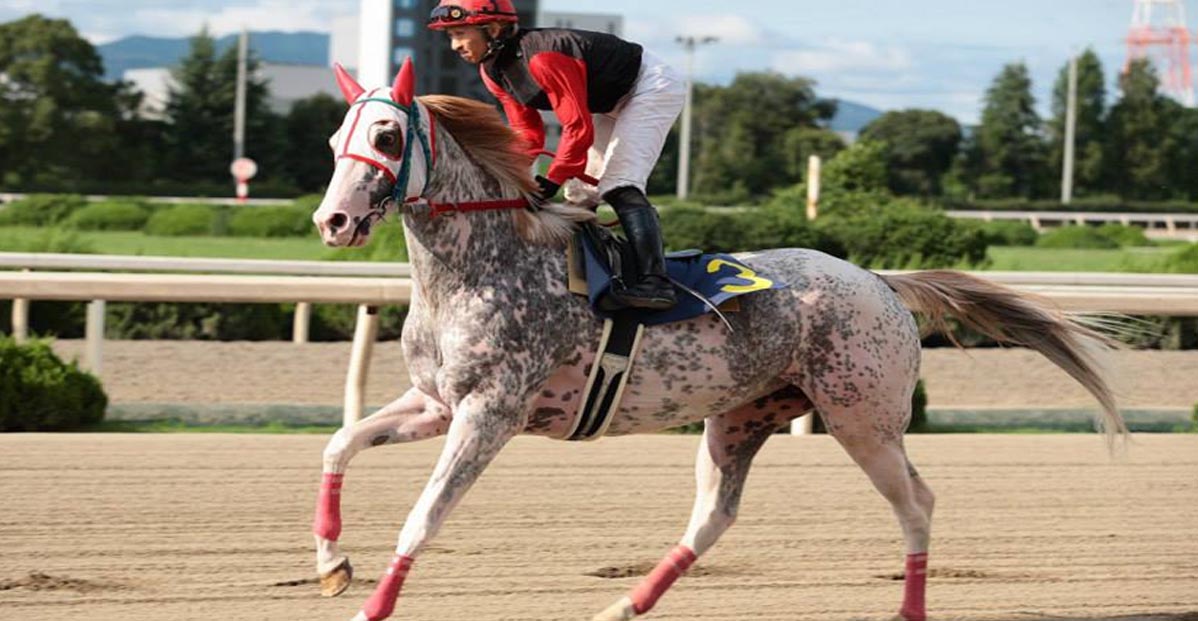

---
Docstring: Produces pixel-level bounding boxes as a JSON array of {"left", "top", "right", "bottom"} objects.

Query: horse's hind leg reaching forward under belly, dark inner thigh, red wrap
[{"left": 594, "top": 387, "right": 810, "bottom": 621}]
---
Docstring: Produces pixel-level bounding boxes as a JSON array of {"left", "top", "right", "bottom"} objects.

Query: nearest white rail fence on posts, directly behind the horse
[{"left": 0, "top": 253, "right": 1198, "bottom": 424}]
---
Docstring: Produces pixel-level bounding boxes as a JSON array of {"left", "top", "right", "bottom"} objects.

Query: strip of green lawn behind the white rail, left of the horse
[{"left": 0, "top": 227, "right": 329, "bottom": 260}]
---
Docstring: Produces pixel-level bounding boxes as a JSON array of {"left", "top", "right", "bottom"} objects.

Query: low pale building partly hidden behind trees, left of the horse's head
[{"left": 122, "top": 62, "right": 341, "bottom": 120}]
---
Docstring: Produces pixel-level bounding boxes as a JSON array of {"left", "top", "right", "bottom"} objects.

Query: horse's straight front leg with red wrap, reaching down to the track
[{"left": 353, "top": 391, "right": 526, "bottom": 621}]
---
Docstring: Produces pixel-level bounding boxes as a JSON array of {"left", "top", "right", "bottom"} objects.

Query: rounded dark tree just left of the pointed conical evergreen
[{"left": 861, "top": 110, "right": 961, "bottom": 197}]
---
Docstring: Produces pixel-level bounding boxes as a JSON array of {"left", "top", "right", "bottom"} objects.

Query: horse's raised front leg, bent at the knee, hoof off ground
[{"left": 311, "top": 388, "right": 449, "bottom": 597}]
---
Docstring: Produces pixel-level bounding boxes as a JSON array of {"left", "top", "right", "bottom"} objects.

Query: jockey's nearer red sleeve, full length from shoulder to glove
[{"left": 528, "top": 52, "right": 595, "bottom": 183}]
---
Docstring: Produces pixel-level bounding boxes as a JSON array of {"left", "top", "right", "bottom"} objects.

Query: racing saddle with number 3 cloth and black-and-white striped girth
[{"left": 565, "top": 223, "right": 785, "bottom": 440}]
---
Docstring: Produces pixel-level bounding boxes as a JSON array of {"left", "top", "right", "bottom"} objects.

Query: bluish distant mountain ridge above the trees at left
[{"left": 96, "top": 31, "right": 328, "bottom": 80}]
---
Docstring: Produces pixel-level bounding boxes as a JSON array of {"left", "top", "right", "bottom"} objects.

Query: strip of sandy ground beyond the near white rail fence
[{"left": 55, "top": 340, "right": 1198, "bottom": 410}]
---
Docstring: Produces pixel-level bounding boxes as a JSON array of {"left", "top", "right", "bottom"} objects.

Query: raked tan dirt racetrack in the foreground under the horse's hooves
[{"left": 0, "top": 434, "right": 1198, "bottom": 621}]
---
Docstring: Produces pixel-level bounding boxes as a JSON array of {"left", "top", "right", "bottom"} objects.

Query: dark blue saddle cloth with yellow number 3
[{"left": 576, "top": 227, "right": 786, "bottom": 326}]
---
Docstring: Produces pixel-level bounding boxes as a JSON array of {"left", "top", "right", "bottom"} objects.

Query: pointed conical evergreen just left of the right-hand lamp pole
[{"left": 967, "top": 62, "right": 1046, "bottom": 198}]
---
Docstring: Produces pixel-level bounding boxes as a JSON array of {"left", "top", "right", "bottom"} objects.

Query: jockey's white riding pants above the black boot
[{"left": 565, "top": 50, "right": 686, "bottom": 206}]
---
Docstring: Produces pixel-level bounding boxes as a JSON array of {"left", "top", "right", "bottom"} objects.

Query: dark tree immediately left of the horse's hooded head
[{"left": 283, "top": 92, "right": 345, "bottom": 192}]
